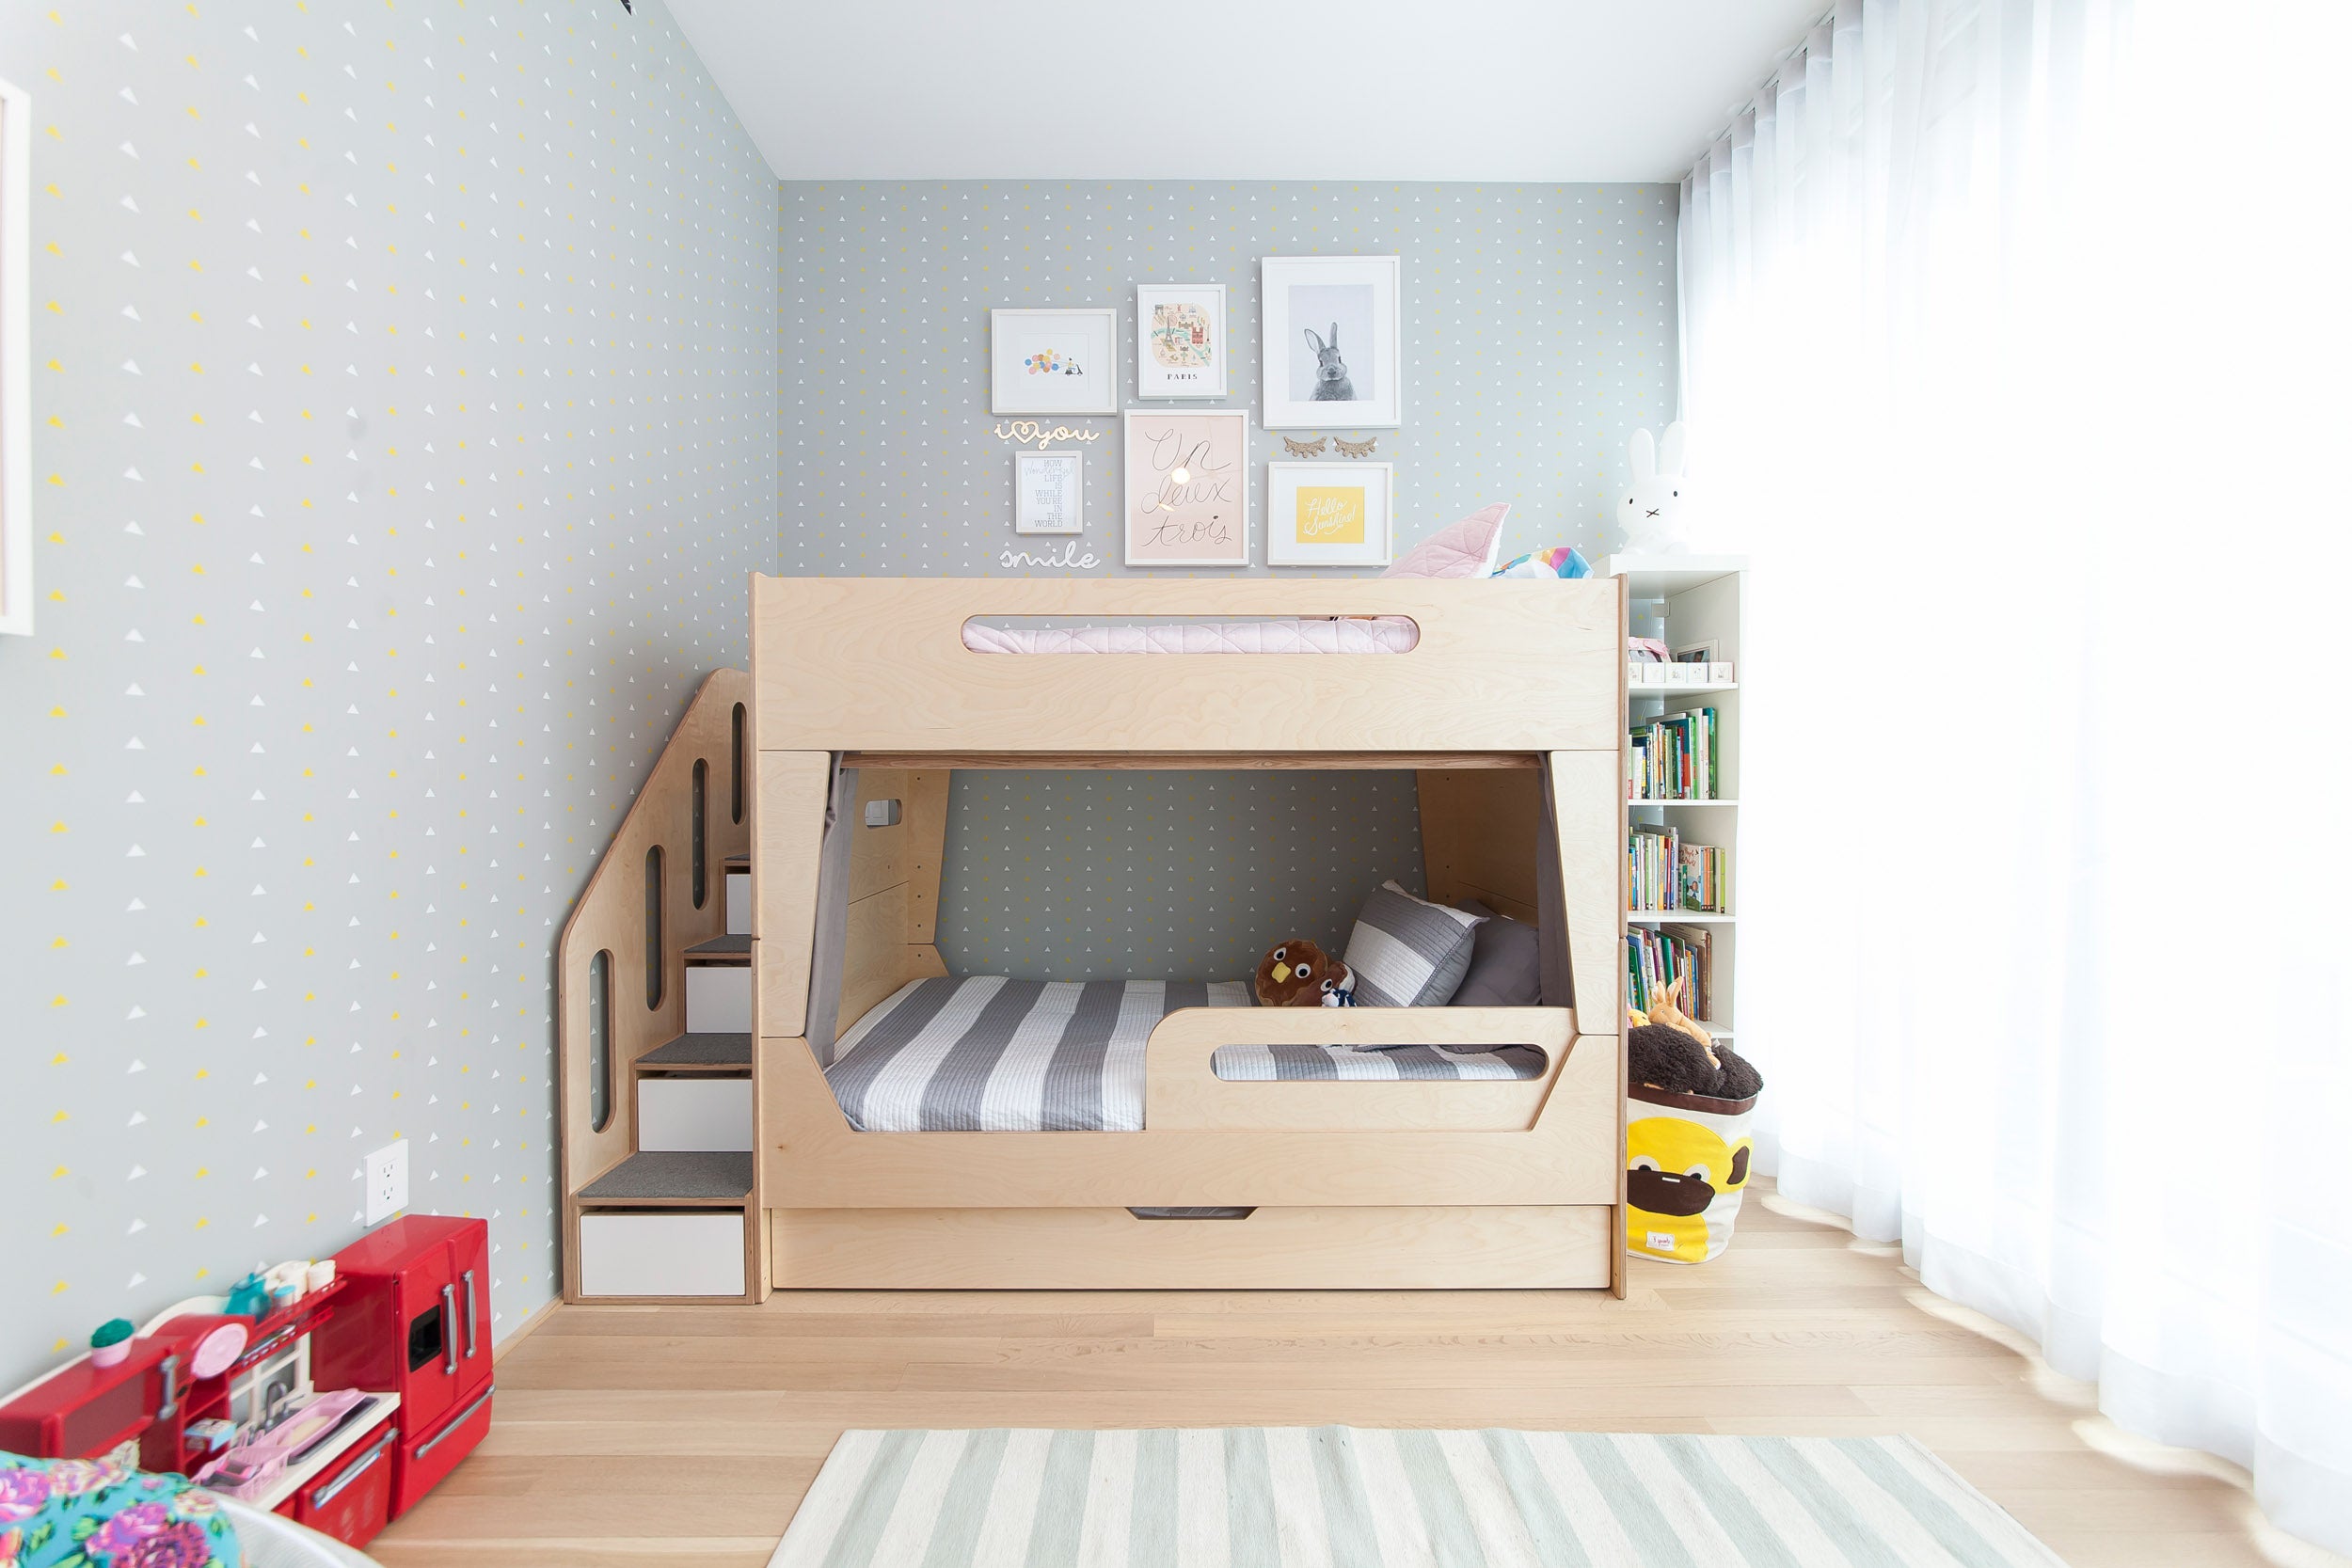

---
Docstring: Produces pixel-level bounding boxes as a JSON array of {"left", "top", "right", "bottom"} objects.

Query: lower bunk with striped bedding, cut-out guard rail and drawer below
[{"left": 760, "top": 991, "right": 1623, "bottom": 1291}]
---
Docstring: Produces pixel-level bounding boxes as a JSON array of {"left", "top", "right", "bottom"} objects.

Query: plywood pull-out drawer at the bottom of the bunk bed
[{"left": 767, "top": 1204, "right": 1618, "bottom": 1291}]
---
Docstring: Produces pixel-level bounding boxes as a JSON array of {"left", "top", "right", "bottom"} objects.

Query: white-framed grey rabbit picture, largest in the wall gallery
[{"left": 1259, "top": 256, "right": 1405, "bottom": 430}]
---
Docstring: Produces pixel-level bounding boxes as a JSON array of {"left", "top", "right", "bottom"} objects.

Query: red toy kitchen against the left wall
[{"left": 0, "top": 1215, "right": 494, "bottom": 1547}]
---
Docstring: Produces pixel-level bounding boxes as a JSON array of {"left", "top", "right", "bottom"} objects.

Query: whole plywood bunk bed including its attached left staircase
[{"left": 558, "top": 578, "right": 1626, "bottom": 1303}]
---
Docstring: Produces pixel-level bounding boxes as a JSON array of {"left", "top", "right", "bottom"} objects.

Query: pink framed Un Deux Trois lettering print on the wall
[{"left": 1120, "top": 409, "right": 1249, "bottom": 566}]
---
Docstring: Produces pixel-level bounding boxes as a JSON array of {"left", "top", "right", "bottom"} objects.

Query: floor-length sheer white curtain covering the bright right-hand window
[{"left": 1682, "top": 0, "right": 2352, "bottom": 1552}]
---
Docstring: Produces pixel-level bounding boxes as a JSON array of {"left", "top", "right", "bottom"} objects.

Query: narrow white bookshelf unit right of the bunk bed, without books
[{"left": 1602, "top": 555, "right": 1750, "bottom": 1037}]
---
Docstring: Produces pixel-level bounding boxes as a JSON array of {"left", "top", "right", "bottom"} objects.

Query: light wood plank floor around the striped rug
[{"left": 372, "top": 1190, "right": 2343, "bottom": 1568}]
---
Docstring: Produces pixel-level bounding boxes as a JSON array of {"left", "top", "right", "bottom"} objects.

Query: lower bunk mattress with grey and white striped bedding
[{"left": 826, "top": 975, "right": 1543, "bottom": 1133}]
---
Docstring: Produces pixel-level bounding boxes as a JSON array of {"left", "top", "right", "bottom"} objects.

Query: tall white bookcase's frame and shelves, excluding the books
[{"left": 1599, "top": 555, "right": 1753, "bottom": 1039}]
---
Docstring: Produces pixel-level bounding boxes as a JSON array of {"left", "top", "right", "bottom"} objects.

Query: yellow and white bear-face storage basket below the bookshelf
[{"left": 1626, "top": 1084, "right": 1757, "bottom": 1262}]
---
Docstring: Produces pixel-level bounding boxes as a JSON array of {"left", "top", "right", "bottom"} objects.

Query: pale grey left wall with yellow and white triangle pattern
[{"left": 0, "top": 0, "right": 776, "bottom": 1387}]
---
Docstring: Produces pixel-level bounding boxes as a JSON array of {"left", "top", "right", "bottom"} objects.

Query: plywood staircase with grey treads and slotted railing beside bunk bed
[{"left": 558, "top": 670, "right": 767, "bottom": 1303}]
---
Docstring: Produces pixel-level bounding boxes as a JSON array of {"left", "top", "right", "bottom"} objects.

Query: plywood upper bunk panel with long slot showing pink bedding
[{"left": 753, "top": 576, "right": 1626, "bottom": 768}]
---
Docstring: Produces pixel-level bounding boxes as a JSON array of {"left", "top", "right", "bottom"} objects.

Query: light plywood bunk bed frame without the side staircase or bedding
[{"left": 748, "top": 578, "right": 1626, "bottom": 1298}]
